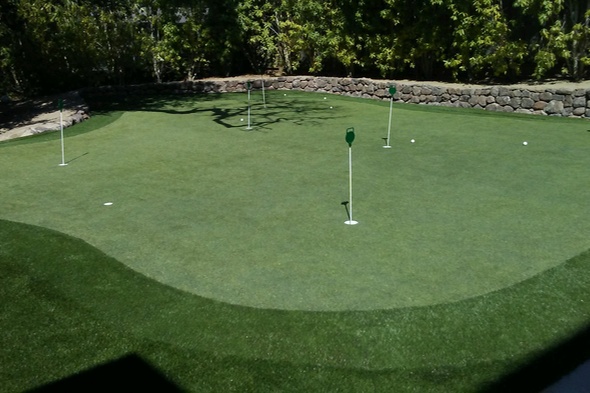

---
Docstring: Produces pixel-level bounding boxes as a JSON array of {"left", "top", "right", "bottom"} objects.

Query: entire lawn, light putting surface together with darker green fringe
[{"left": 0, "top": 91, "right": 590, "bottom": 392}]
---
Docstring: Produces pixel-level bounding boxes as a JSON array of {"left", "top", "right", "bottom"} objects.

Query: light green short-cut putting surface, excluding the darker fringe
[{"left": 0, "top": 92, "right": 590, "bottom": 311}]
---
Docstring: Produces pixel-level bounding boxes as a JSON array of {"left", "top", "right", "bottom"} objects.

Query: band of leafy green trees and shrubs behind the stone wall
[{"left": 0, "top": 0, "right": 590, "bottom": 94}]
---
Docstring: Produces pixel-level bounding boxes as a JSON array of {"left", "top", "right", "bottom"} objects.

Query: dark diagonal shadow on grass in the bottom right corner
[{"left": 482, "top": 326, "right": 590, "bottom": 393}]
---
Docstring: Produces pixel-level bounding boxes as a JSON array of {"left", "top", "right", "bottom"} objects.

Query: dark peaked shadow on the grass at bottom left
[{"left": 30, "top": 354, "right": 183, "bottom": 393}]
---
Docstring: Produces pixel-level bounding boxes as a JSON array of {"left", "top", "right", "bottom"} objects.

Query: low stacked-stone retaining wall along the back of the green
[{"left": 83, "top": 76, "right": 590, "bottom": 118}]
